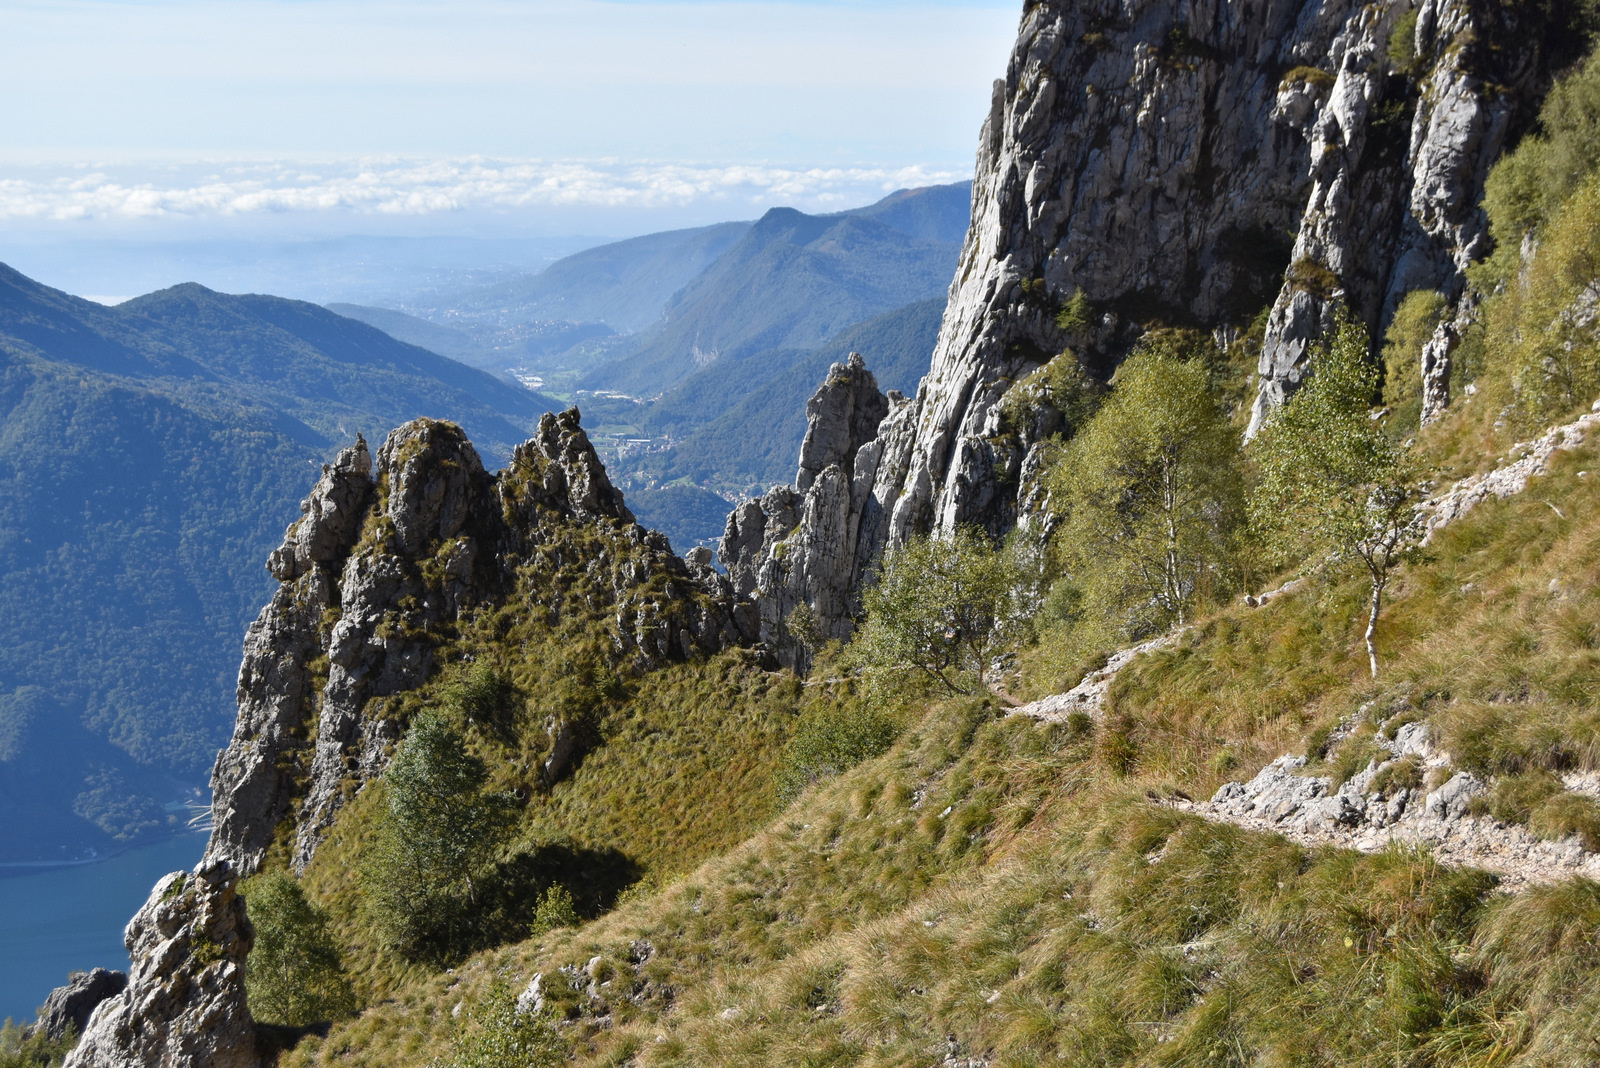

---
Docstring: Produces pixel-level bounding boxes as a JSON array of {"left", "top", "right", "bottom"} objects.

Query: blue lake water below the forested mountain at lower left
[{"left": 0, "top": 835, "right": 205, "bottom": 1022}]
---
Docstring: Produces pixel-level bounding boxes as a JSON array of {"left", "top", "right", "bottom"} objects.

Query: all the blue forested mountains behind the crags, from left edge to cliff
[{"left": 0, "top": 185, "right": 970, "bottom": 863}]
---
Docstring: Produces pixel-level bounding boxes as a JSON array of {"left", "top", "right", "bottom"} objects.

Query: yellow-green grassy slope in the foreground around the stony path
[{"left": 285, "top": 404, "right": 1600, "bottom": 1065}]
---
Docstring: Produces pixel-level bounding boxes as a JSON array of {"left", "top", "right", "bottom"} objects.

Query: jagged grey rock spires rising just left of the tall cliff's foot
[{"left": 720, "top": 352, "right": 907, "bottom": 668}]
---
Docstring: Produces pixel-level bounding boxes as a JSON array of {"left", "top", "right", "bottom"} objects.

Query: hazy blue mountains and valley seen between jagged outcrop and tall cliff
[{"left": 330, "top": 182, "right": 971, "bottom": 548}]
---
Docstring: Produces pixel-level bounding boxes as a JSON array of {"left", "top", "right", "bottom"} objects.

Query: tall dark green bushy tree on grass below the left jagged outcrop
[{"left": 363, "top": 710, "right": 517, "bottom": 962}]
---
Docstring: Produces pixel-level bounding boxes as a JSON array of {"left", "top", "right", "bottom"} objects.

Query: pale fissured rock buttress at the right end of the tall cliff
[{"left": 1250, "top": 0, "right": 1547, "bottom": 433}]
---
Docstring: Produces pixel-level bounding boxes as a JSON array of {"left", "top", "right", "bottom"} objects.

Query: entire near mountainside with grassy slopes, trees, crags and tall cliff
[{"left": 40, "top": 0, "right": 1600, "bottom": 1068}]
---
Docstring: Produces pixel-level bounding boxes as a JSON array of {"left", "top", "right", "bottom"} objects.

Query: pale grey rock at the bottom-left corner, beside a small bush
[{"left": 66, "top": 863, "right": 261, "bottom": 1068}]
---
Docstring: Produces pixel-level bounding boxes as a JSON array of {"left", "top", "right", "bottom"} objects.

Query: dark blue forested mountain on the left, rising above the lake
[{"left": 0, "top": 265, "right": 557, "bottom": 862}]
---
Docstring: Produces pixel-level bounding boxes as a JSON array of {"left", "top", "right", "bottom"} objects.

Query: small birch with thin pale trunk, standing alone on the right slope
[{"left": 1250, "top": 318, "right": 1421, "bottom": 678}]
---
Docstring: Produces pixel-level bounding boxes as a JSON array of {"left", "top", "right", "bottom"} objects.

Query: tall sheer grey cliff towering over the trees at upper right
[{"left": 755, "top": 0, "right": 1571, "bottom": 655}]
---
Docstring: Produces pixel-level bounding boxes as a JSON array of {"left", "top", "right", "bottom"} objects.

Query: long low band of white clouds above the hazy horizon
[{"left": 0, "top": 158, "right": 968, "bottom": 222}]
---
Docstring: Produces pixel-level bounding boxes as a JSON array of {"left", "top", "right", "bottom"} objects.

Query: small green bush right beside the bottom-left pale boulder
[{"left": 245, "top": 871, "right": 355, "bottom": 1026}]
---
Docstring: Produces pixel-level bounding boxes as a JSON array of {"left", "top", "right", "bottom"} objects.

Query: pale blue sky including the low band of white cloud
[{"left": 0, "top": 0, "right": 1021, "bottom": 235}]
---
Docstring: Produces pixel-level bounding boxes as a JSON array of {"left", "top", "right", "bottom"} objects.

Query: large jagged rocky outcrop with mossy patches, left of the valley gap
[{"left": 206, "top": 409, "right": 741, "bottom": 875}]
